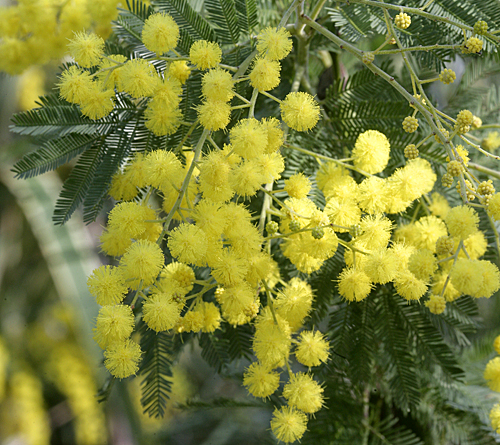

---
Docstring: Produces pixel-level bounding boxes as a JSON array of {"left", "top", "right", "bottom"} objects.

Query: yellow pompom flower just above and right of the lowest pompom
[{"left": 283, "top": 372, "right": 324, "bottom": 414}]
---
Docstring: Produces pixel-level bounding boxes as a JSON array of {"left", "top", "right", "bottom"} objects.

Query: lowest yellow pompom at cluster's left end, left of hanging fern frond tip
[{"left": 104, "top": 339, "right": 142, "bottom": 379}]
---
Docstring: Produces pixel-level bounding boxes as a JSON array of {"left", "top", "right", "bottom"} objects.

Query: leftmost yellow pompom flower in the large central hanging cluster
[{"left": 87, "top": 266, "right": 128, "bottom": 306}]
